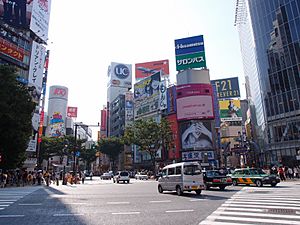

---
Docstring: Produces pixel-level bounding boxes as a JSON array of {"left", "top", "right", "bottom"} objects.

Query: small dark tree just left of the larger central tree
[{"left": 98, "top": 137, "right": 124, "bottom": 169}]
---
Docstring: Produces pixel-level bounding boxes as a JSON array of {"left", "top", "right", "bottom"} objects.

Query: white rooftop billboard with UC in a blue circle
[{"left": 107, "top": 62, "right": 132, "bottom": 89}]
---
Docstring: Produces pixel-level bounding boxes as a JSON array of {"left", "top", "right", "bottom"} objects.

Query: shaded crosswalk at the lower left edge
[{"left": 0, "top": 188, "right": 38, "bottom": 212}]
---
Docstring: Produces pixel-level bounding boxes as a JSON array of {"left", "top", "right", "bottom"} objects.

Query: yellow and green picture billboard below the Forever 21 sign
[{"left": 219, "top": 100, "right": 242, "bottom": 121}]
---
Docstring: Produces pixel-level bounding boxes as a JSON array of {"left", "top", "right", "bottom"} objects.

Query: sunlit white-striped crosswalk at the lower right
[{"left": 199, "top": 184, "right": 300, "bottom": 225}]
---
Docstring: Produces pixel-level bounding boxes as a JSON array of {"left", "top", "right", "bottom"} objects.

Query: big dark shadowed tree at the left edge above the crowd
[{"left": 0, "top": 65, "right": 35, "bottom": 169}]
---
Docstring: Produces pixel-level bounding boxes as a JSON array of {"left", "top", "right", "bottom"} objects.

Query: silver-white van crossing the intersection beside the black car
[{"left": 158, "top": 162, "right": 204, "bottom": 195}]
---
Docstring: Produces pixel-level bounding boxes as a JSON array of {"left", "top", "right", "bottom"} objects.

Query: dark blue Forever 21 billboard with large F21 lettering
[{"left": 211, "top": 77, "right": 240, "bottom": 99}]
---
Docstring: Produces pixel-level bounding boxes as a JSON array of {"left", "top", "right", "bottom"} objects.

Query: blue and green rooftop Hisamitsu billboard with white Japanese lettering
[{"left": 175, "top": 35, "right": 206, "bottom": 71}]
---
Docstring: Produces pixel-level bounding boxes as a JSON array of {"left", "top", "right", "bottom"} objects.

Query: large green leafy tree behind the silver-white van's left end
[{"left": 124, "top": 118, "right": 173, "bottom": 171}]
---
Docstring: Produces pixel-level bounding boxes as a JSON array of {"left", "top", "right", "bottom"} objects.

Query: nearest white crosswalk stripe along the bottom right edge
[{"left": 207, "top": 215, "right": 299, "bottom": 225}]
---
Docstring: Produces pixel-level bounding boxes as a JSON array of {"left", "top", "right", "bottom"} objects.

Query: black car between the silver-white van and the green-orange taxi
[{"left": 203, "top": 170, "right": 232, "bottom": 190}]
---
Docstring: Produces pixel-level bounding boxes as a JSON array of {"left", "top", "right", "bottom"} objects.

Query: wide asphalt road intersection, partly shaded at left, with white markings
[{"left": 0, "top": 177, "right": 300, "bottom": 225}]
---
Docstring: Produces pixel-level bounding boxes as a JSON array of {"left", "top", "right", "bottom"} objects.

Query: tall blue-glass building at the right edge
[{"left": 235, "top": 0, "right": 300, "bottom": 166}]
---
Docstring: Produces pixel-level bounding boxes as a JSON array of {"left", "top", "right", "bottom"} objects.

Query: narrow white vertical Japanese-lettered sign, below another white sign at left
[{"left": 28, "top": 41, "right": 46, "bottom": 103}]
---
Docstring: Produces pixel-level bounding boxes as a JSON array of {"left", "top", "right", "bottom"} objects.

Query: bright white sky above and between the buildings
[{"left": 46, "top": 0, "right": 246, "bottom": 140}]
